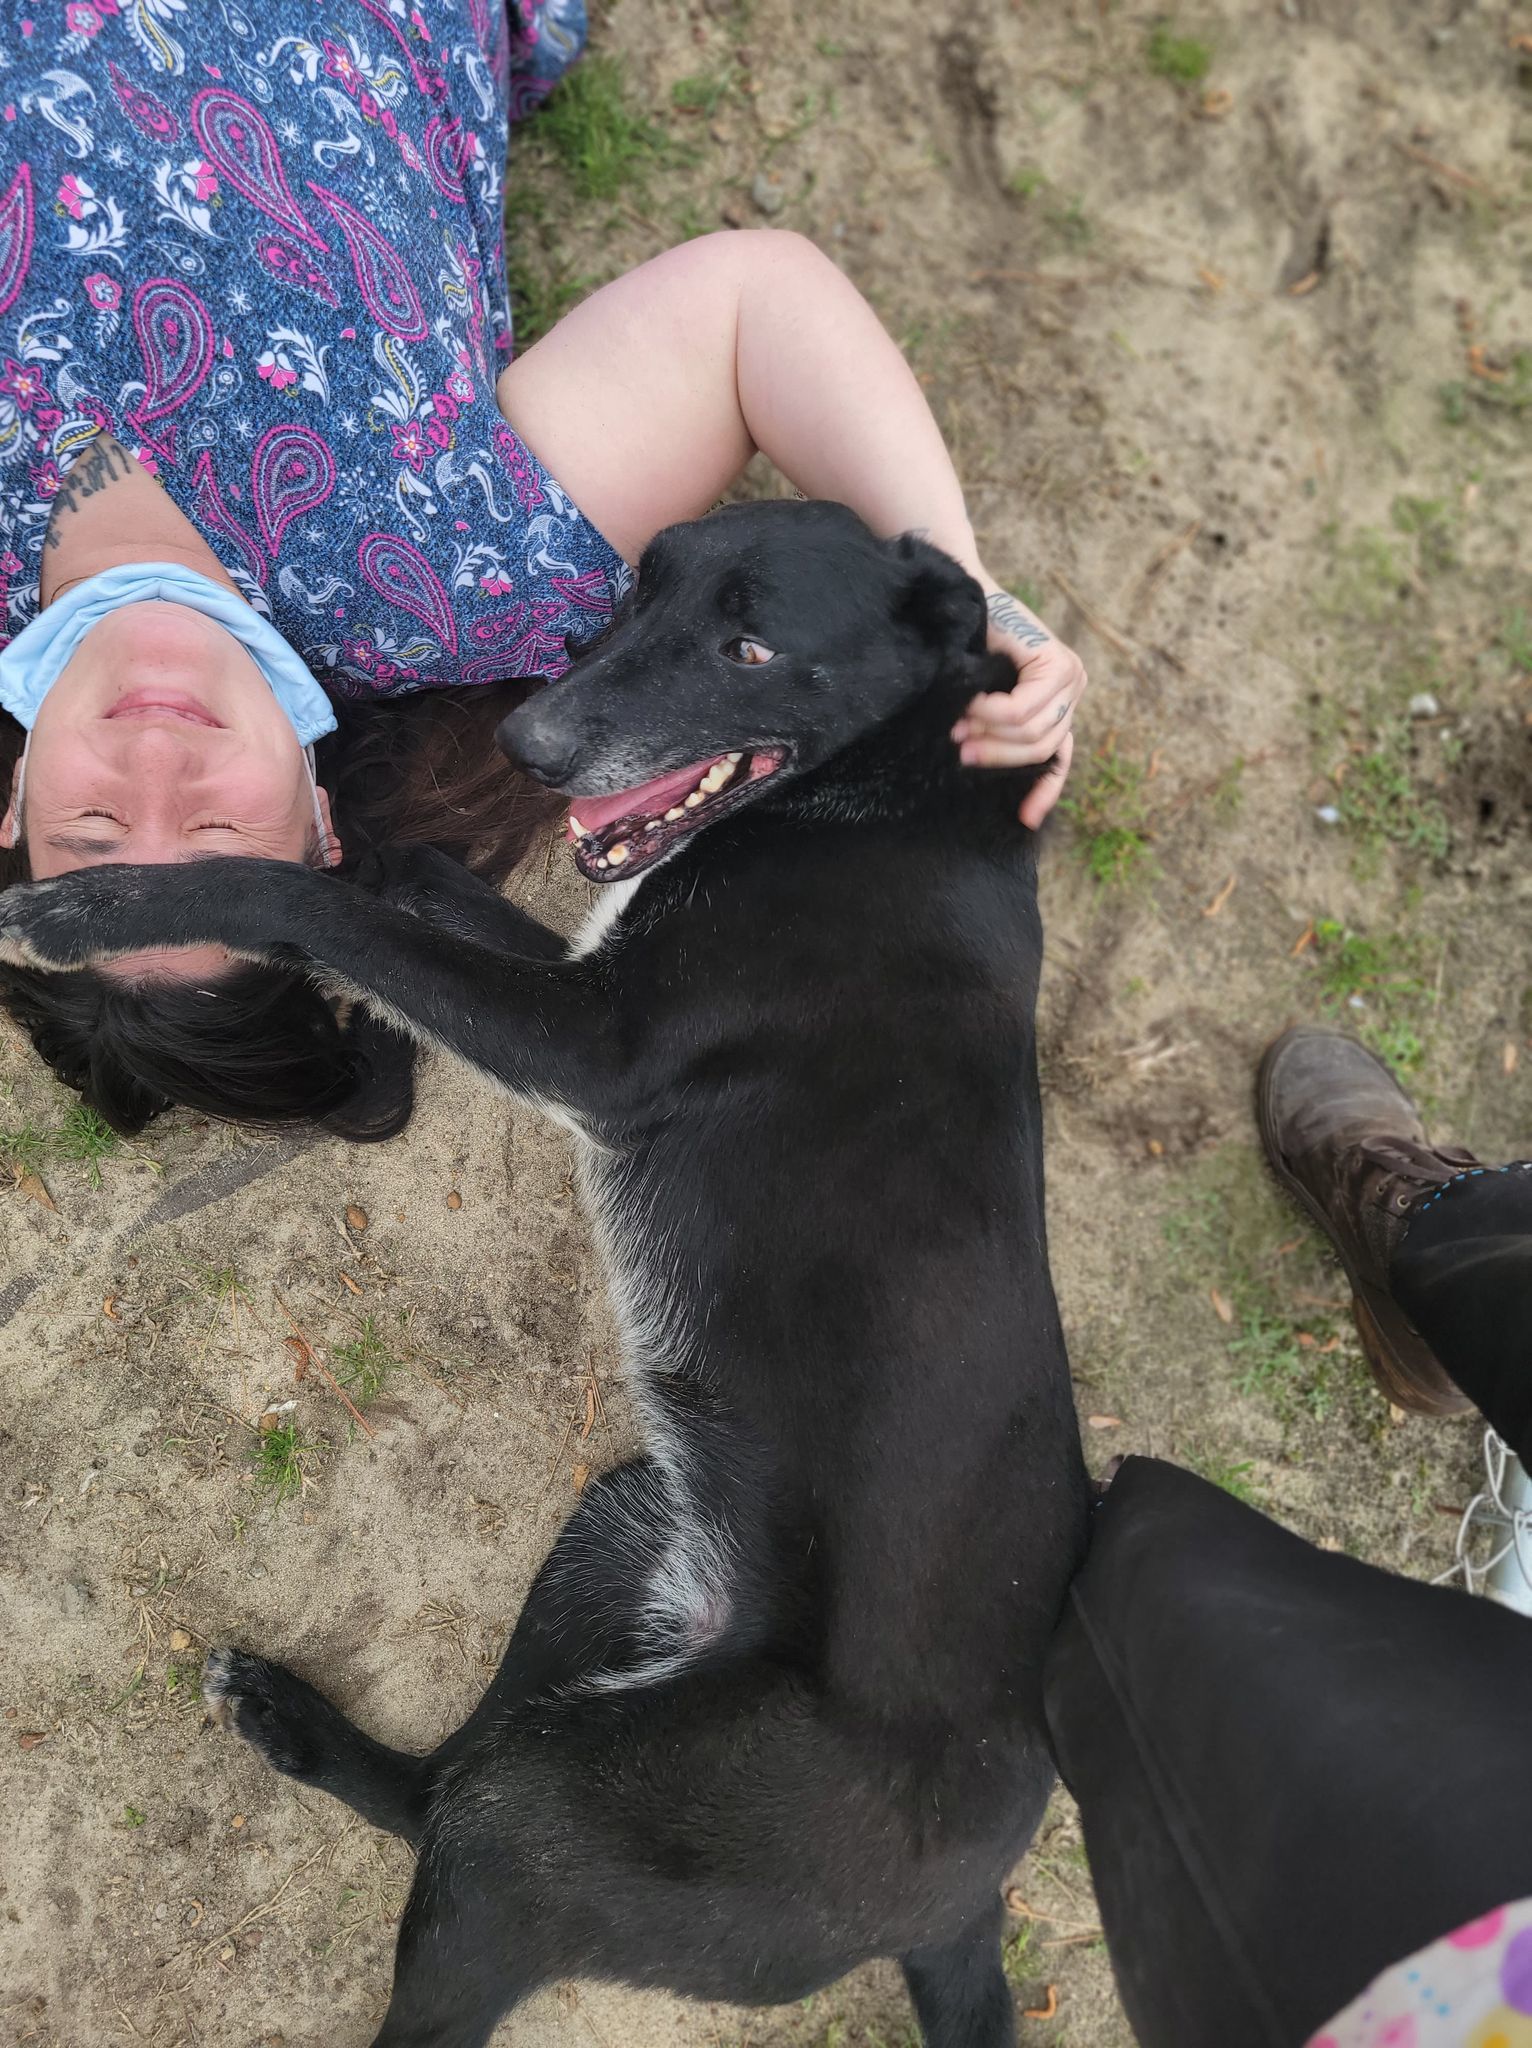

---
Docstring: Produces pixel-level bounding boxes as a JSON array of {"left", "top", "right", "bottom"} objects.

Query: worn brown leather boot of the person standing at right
[{"left": 1256, "top": 1024, "right": 1479, "bottom": 1415}]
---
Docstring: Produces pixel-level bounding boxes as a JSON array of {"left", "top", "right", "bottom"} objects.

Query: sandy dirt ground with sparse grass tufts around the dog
[{"left": 0, "top": 0, "right": 1532, "bottom": 2048}]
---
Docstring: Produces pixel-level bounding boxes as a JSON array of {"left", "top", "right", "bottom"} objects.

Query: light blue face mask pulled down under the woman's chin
[{"left": 0, "top": 561, "right": 336, "bottom": 854}]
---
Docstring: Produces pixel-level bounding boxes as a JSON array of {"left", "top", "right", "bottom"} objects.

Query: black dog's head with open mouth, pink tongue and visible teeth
[{"left": 498, "top": 500, "right": 985, "bottom": 883}]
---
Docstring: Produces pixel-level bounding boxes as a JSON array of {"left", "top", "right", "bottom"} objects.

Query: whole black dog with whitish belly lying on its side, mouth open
[{"left": 0, "top": 504, "right": 1088, "bottom": 2048}]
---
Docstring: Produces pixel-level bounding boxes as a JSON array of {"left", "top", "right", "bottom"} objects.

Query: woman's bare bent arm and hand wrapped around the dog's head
[{"left": 500, "top": 229, "right": 1086, "bottom": 825}]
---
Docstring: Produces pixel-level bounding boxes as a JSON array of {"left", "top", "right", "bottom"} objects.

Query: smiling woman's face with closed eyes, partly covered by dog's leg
[{"left": 0, "top": 600, "right": 328, "bottom": 975}]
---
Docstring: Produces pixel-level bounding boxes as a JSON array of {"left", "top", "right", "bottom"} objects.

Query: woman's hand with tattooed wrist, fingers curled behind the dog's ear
[{"left": 952, "top": 575, "right": 1088, "bottom": 831}]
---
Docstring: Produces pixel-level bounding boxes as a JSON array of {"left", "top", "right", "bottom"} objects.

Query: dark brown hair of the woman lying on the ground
[{"left": 0, "top": 682, "right": 559, "bottom": 1141}]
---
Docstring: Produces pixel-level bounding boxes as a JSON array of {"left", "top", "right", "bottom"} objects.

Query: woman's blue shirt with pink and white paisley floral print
[{"left": 0, "top": 0, "right": 629, "bottom": 696}]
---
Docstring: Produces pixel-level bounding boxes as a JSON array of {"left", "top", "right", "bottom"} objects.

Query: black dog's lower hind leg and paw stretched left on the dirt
[{"left": 203, "top": 1651, "right": 426, "bottom": 1841}]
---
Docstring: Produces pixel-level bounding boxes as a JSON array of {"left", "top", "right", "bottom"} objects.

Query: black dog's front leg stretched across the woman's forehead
[{"left": 0, "top": 860, "right": 621, "bottom": 1116}]
